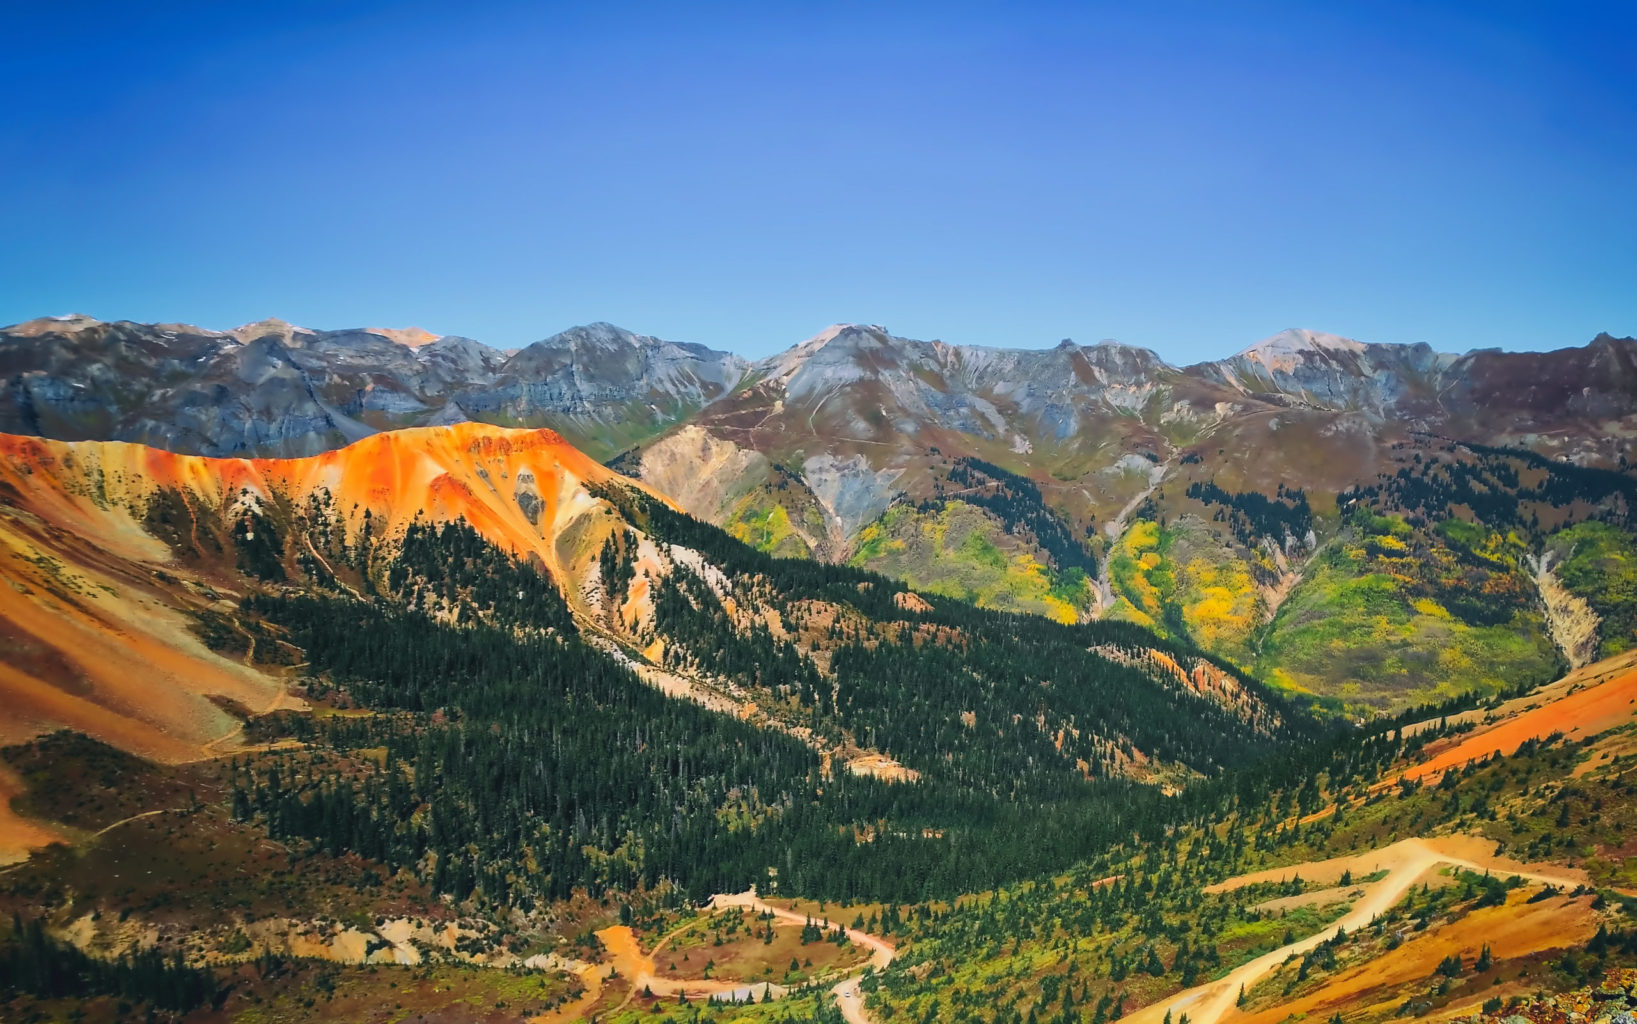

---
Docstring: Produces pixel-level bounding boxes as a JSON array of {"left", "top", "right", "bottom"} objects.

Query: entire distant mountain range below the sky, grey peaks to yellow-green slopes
[{"left": 9, "top": 310, "right": 1637, "bottom": 710}]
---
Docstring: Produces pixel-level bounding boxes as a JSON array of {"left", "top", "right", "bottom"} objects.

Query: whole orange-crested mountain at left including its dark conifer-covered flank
[{"left": 0, "top": 425, "right": 1318, "bottom": 903}]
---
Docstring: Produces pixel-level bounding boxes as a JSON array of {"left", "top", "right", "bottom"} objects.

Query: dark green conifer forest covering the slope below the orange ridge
[{"left": 232, "top": 503, "right": 1321, "bottom": 906}]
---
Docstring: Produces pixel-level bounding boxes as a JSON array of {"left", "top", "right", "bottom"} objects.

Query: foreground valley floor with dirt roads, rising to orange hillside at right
[{"left": 9, "top": 644, "right": 1637, "bottom": 1024}]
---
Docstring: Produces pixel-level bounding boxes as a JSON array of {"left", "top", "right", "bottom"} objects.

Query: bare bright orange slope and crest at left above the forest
[{"left": 0, "top": 424, "right": 664, "bottom": 761}]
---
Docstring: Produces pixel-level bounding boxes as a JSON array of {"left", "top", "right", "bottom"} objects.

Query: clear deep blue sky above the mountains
[{"left": 0, "top": 0, "right": 1637, "bottom": 362}]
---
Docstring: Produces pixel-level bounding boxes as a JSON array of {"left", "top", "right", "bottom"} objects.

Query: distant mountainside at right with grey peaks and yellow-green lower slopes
[{"left": 612, "top": 326, "right": 1637, "bottom": 707}]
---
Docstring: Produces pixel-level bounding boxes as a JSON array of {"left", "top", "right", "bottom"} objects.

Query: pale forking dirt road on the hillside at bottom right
[{"left": 1125, "top": 838, "right": 1585, "bottom": 1024}]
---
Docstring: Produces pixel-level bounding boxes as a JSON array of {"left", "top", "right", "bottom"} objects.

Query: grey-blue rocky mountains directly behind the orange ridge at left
[{"left": 0, "top": 310, "right": 748, "bottom": 456}]
